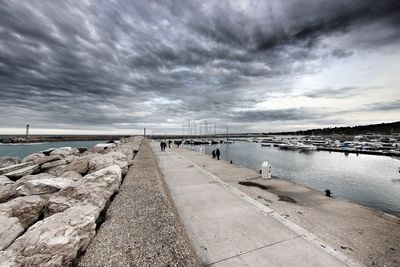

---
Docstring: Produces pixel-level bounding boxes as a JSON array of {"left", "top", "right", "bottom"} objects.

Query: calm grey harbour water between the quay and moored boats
[{"left": 199, "top": 142, "right": 400, "bottom": 217}]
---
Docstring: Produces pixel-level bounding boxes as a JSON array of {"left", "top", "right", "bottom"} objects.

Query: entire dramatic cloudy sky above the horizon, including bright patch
[{"left": 0, "top": 0, "right": 400, "bottom": 134}]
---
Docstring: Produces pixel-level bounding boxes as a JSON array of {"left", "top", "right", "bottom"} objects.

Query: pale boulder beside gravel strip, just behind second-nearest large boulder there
[{"left": 89, "top": 151, "right": 128, "bottom": 175}]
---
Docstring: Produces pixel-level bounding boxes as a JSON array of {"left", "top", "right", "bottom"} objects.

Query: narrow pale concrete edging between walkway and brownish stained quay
[{"left": 171, "top": 150, "right": 365, "bottom": 267}]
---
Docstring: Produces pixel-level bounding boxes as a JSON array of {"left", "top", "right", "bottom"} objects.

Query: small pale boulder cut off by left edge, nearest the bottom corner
[{"left": 0, "top": 212, "right": 24, "bottom": 250}]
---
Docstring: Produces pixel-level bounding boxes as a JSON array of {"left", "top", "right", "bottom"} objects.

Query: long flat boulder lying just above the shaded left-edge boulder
[{"left": 16, "top": 178, "right": 75, "bottom": 196}]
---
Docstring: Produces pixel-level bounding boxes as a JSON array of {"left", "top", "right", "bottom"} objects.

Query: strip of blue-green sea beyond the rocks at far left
[{"left": 0, "top": 141, "right": 105, "bottom": 159}]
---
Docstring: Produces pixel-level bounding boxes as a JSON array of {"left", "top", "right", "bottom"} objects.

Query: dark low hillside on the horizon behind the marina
[{"left": 275, "top": 121, "right": 400, "bottom": 135}]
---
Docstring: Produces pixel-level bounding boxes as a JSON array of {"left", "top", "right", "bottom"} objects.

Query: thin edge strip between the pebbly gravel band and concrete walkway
[{"left": 146, "top": 138, "right": 204, "bottom": 266}]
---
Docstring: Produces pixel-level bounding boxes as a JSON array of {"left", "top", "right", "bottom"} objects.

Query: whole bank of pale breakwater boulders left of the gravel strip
[{"left": 0, "top": 137, "right": 141, "bottom": 266}]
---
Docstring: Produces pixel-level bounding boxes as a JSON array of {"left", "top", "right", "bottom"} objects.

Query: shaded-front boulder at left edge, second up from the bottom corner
[{"left": 0, "top": 196, "right": 46, "bottom": 229}]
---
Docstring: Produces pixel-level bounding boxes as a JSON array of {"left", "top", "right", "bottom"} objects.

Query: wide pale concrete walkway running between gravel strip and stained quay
[{"left": 151, "top": 142, "right": 357, "bottom": 266}]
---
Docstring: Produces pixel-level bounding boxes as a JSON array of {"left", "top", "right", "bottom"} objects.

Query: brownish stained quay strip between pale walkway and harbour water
[{"left": 173, "top": 148, "right": 400, "bottom": 266}]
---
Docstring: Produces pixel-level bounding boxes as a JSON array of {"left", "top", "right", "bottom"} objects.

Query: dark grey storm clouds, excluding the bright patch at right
[{"left": 0, "top": 0, "right": 400, "bottom": 133}]
